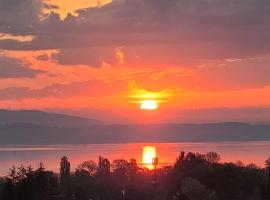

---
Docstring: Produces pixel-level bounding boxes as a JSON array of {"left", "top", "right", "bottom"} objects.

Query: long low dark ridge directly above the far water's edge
[{"left": 0, "top": 123, "right": 270, "bottom": 145}]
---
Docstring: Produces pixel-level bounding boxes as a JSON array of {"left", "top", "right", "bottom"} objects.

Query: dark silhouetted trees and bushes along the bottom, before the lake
[{"left": 0, "top": 152, "right": 270, "bottom": 200}]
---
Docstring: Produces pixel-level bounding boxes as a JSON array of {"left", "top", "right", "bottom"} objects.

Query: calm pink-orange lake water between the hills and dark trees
[{"left": 0, "top": 141, "right": 270, "bottom": 176}]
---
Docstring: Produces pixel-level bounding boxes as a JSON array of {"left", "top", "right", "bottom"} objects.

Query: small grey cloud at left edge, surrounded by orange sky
[{"left": 0, "top": 54, "right": 44, "bottom": 79}]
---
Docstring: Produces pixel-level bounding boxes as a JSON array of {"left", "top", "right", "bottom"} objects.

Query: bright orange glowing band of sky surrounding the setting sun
[{"left": 0, "top": 50, "right": 270, "bottom": 123}]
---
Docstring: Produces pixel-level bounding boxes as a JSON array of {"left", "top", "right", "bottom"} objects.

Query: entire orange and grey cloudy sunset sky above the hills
[{"left": 0, "top": 0, "right": 270, "bottom": 123}]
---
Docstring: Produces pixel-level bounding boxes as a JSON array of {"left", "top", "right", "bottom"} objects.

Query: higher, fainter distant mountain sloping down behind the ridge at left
[{"left": 0, "top": 110, "right": 100, "bottom": 127}]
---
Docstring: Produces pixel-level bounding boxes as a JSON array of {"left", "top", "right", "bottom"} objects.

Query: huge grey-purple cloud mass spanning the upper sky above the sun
[{"left": 0, "top": 0, "right": 270, "bottom": 90}]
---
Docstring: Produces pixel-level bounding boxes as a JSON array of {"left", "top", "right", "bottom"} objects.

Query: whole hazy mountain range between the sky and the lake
[{"left": 0, "top": 110, "right": 270, "bottom": 145}]
